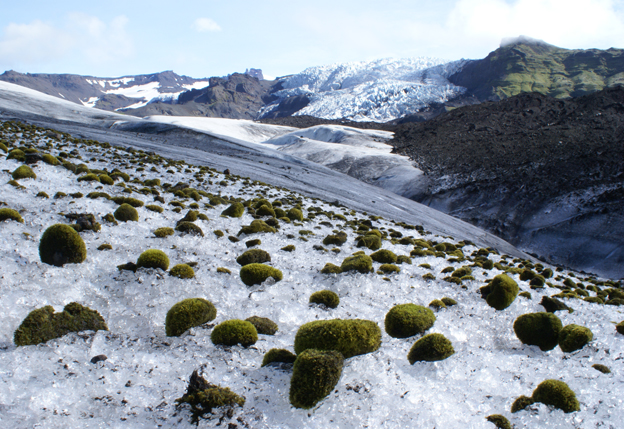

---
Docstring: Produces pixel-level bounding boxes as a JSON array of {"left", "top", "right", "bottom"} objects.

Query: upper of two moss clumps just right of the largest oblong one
[{"left": 384, "top": 304, "right": 436, "bottom": 338}]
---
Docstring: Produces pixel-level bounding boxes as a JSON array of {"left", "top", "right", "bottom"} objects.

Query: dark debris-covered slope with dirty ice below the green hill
[{"left": 391, "top": 87, "right": 624, "bottom": 277}]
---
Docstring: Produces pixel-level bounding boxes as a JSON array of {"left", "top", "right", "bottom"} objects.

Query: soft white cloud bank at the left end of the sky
[{"left": 0, "top": 13, "right": 134, "bottom": 68}]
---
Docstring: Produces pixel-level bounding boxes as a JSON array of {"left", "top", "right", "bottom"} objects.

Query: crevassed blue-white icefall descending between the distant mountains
[{"left": 261, "top": 58, "right": 465, "bottom": 122}]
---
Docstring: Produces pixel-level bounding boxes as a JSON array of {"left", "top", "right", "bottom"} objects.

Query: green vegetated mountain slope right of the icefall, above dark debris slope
[{"left": 449, "top": 42, "right": 624, "bottom": 101}]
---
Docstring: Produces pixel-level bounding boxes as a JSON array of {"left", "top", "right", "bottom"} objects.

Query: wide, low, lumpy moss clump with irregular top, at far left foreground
[{"left": 13, "top": 302, "right": 108, "bottom": 346}]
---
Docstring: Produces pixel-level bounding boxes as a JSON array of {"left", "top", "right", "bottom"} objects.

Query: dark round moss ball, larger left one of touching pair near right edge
[{"left": 514, "top": 313, "right": 563, "bottom": 351}]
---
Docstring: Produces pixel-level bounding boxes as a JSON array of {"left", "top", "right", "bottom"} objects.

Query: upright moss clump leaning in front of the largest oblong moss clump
[{"left": 289, "top": 349, "right": 344, "bottom": 409}]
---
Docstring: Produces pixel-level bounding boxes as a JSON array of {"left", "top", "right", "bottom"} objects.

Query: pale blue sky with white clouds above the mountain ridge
[{"left": 0, "top": 0, "right": 624, "bottom": 78}]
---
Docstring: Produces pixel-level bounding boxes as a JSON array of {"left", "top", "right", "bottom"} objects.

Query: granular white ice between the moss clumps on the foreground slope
[{"left": 0, "top": 123, "right": 624, "bottom": 429}]
